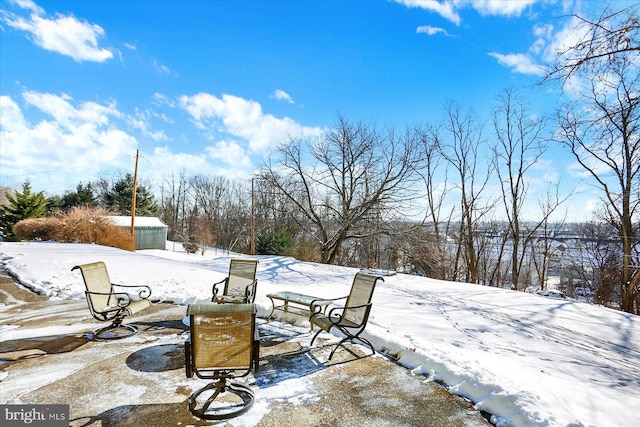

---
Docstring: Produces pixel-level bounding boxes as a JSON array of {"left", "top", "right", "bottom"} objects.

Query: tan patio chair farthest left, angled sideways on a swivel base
[{"left": 71, "top": 261, "right": 151, "bottom": 339}]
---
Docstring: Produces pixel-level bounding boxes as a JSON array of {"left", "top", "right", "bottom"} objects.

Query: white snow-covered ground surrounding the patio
[{"left": 0, "top": 242, "right": 640, "bottom": 427}]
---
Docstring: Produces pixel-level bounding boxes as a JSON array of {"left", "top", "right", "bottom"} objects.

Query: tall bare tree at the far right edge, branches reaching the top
[{"left": 547, "top": 5, "right": 640, "bottom": 312}]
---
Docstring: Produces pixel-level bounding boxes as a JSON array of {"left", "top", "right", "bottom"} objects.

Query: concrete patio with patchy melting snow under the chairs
[{"left": 0, "top": 277, "right": 490, "bottom": 427}]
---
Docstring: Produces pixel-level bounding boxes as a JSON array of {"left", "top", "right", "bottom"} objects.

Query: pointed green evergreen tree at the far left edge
[{"left": 0, "top": 180, "right": 47, "bottom": 240}]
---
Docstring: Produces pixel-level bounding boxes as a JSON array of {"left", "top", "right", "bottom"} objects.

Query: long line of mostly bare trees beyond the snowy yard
[{"left": 0, "top": 3, "right": 640, "bottom": 313}]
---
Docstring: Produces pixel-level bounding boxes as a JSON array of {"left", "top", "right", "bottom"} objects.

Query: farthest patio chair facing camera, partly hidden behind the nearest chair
[{"left": 211, "top": 258, "right": 258, "bottom": 304}]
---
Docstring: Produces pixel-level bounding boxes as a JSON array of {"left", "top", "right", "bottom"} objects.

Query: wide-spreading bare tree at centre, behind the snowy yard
[{"left": 261, "top": 117, "right": 419, "bottom": 264}]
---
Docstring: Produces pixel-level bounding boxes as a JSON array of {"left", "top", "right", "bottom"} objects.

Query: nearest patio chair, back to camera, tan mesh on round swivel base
[{"left": 184, "top": 303, "right": 260, "bottom": 420}]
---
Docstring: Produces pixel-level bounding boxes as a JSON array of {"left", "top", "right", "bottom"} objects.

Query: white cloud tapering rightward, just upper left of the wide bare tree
[{"left": 179, "top": 92, "right": 320, "bottom": 154}]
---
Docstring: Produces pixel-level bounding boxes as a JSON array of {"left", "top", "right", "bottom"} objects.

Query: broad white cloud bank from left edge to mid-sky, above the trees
[{"left": 0, "top": 90, "right": 320, "bottom": 194}]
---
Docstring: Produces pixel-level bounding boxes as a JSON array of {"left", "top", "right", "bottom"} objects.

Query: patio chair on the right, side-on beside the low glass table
[{"left": 309, "top": 273, "right": 384, "bottom": 360}]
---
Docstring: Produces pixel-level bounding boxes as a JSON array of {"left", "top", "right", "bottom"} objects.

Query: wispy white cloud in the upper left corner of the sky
[{"left": 2, "top": 1, "right": 113, "bottom": 62}]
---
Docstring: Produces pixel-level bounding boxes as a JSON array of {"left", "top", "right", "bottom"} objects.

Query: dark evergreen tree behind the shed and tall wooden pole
[{"left": 102, "top": 174, "right": 158, "bottom": 216}]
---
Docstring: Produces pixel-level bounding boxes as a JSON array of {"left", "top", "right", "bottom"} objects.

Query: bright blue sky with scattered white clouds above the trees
[{"left": 0, "top": 0, "right": 631, "bottom": 218}]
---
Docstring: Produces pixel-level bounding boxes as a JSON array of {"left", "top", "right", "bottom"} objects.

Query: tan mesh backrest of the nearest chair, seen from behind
[{"left": 187, "top": 304, "right": 256, "bottom": 378}]
